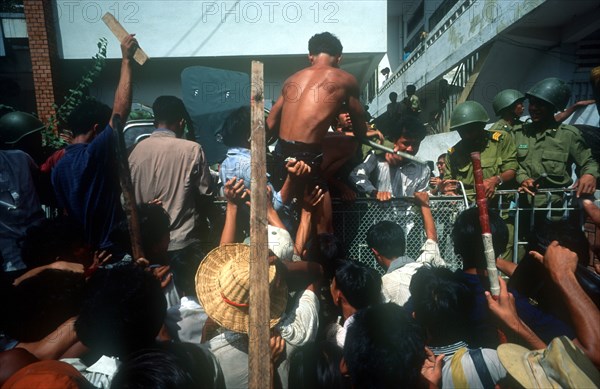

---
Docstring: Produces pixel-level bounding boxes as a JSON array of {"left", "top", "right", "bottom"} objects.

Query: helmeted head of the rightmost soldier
[{"left": 525, "top": 77, "right": 571, "bottom": 123}]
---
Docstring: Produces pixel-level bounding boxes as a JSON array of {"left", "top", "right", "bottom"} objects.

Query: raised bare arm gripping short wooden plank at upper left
[{"left": 110, "top": 34, "right": 138, "bottom": 128}]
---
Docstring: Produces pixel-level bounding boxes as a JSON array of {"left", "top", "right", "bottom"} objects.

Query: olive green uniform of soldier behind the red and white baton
[{"left": 444, "top": 131, "right": 519, "bottom": 201}]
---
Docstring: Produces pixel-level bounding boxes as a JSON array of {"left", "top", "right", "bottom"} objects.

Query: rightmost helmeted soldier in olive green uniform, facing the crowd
[{"left": 513, "top": 78, "right": 598, "bottom": 206}]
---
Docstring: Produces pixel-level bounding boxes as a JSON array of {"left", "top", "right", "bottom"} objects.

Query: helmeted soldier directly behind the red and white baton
[{"left": 442, "top": 101, "right": 518, "bottom": 201}]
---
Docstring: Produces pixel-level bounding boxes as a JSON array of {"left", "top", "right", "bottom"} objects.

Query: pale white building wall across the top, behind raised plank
[{"left": 56, "top": 0, "right": 387, "bottom": 59}]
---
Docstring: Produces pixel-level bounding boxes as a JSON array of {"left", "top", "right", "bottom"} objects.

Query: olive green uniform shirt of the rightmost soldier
[{"left": 513, "top": 123, "right": 598, "bottom": 192}]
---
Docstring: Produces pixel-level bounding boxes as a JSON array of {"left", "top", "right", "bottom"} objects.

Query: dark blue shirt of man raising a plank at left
[{"left": 52, "top": 126, "right": 125, "bottom": 249}]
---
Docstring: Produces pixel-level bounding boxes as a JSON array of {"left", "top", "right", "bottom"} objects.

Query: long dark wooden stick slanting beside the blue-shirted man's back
[{"left": 112, "top": 114, "right": 144, "bottom": 261}]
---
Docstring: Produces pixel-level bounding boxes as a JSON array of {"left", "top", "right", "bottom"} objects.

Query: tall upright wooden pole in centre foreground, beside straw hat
[{"left": 248, "top": 61, "right": 271, "bottom": 389}]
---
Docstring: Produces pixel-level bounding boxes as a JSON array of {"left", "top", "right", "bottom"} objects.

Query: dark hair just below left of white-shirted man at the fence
[{"left": 335, "top": 261, "right": 381, "bottom": 309}]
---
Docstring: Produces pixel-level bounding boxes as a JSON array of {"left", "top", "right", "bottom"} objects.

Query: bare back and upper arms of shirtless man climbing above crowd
[{"left": 267, "top": 53, "right": 366, "bottom": 144}]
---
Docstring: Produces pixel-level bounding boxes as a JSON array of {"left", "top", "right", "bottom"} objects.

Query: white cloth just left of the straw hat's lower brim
[{"left": 165, "top": 296, "right": 208, "bottom": 345}]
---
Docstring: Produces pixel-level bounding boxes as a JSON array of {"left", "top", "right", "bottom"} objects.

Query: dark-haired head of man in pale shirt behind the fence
[{"left": 385, "top": 116, "right": 427, "bottom": 166}]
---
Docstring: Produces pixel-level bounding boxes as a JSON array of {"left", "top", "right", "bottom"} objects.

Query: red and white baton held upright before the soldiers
[{"left": 471, "top": 152, "right": 500, "bottom": 296}]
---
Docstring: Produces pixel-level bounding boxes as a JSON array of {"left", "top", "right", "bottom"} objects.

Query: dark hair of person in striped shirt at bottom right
[{"left": 410, "top": 266, "right": 475, "bottom": 346}]
